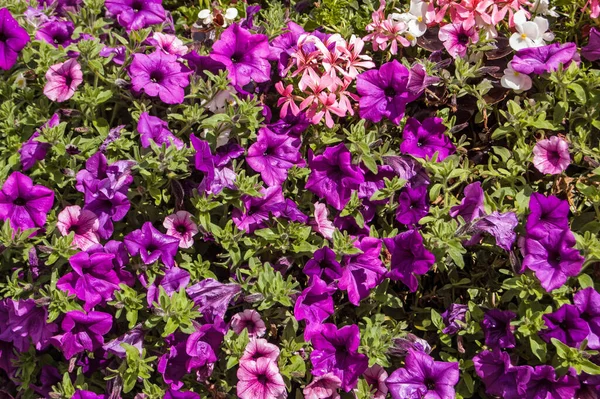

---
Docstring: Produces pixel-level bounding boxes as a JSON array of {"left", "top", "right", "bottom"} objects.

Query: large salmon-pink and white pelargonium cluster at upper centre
[{"left": 275, "top": 33, "right": 375, "bottom": 128}]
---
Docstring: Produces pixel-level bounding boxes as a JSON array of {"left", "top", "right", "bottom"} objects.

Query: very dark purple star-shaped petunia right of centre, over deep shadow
[{"left": 383, "top": 230, "right": 435, "bottom": 292}]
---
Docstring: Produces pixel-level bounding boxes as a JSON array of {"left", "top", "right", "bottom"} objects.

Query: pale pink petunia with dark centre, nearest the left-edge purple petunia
[{"left": 56, "top": 205, "right": 100, "bottom": 251}]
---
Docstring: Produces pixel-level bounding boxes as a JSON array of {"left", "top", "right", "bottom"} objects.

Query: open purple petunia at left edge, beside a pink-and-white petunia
[{"left": 0, "top": 172, "right": 54, "bottom": 230}]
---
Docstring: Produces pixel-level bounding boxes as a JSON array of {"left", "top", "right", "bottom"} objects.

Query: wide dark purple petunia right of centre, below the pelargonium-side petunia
[{"left": 400, "top": 118, "right": 456, "bottom": 162}]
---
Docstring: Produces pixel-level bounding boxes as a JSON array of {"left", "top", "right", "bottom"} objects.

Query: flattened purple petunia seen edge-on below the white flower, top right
[{"left": 512, "top": 43, "right": 579, "bottom": 75}]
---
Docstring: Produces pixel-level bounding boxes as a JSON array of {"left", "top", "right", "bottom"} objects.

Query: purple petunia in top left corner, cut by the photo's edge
[{"left": 0, "top": 8, "right": 29, "bottom": 71}]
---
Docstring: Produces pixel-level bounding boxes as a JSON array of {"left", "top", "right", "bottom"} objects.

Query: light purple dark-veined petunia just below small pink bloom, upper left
[{"left": 129, "top": 51, "right": 192, "bottom": 104}]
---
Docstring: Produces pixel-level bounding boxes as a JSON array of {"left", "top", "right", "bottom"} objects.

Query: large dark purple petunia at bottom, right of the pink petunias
[{"left": 310, "top": 323, "right": 369, "bottom": 392}]
